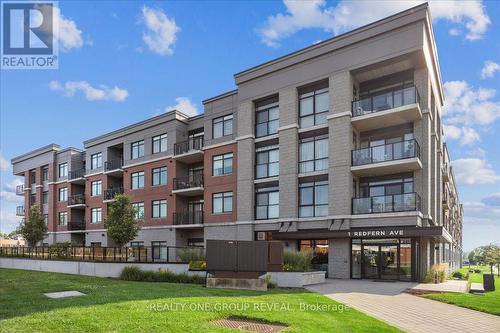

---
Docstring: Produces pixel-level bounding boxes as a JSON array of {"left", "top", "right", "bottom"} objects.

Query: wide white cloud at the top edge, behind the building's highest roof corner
[{"left": 258, "top": 0, "right": 491, "bottom": 46}]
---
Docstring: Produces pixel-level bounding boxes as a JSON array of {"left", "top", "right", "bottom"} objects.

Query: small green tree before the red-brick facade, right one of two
[{"left": 104, "top": 194, "right": 140, "bottom": 247}]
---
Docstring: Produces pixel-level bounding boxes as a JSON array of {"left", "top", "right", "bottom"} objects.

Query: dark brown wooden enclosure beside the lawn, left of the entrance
[{"left": 206, "top": 240, "right": 283, "bottom": 278}]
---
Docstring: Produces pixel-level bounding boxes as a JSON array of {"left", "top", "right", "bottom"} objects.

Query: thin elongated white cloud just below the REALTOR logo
[{"left": 49, "top": 81, "right": 128, "bottom": 102}]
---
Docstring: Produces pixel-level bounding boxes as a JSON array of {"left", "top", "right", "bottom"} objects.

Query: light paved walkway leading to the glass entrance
[{"left": 307, "top": 279, "right": 500, "bottom": 333}]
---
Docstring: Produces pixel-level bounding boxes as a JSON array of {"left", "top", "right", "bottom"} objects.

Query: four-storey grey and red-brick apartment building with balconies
[{"left": 12, "top": 4, "right": 463, "bottom": 281}]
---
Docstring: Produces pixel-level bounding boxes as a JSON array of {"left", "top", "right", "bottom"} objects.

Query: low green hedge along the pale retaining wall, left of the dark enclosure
[{"left": 120, "top": 266, "right": 205, "bottom": 284}]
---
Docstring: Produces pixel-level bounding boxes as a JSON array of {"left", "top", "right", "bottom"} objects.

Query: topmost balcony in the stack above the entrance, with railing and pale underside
[{"left": 351, "top": 86, "right": 422, "bottom": 131}]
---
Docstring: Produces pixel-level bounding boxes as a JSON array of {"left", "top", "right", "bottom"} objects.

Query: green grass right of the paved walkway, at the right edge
[{"left": 423, "top": 266, "right": 500, "bottom": 316}]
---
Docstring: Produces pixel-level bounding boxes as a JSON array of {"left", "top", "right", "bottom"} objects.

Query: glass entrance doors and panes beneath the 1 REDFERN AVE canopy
[{"left": 351, "top": 238, "right": 418, "bottom": 281}]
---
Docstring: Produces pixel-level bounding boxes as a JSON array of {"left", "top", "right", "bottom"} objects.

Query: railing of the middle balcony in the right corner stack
[{"left": 351, "top": 139, "right": 420, "bottom": 166}]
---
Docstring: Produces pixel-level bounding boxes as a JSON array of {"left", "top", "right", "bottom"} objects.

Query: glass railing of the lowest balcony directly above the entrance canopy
[{"left": 352, "top": 192, "right": 421, "bottom": 215}]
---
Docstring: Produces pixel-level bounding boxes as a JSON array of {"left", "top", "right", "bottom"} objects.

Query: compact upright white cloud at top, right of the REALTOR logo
[{"left": 142, "top": 6, "right": 181, "bottom": 55}]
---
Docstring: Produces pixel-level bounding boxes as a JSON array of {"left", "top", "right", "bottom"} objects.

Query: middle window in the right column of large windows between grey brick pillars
[{"left": 299, "top": 136, "right": 328, "bottom": 173}]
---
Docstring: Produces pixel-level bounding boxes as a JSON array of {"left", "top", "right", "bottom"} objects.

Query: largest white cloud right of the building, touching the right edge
[{"left": 443, "top": 81, "right": 500, "bottom": 126}]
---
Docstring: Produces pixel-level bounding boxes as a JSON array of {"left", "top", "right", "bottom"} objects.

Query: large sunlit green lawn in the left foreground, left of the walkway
[{"left": 0, "top": 269, "right": 400, "bottom": 333}]
